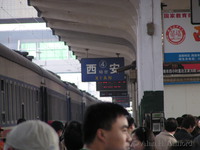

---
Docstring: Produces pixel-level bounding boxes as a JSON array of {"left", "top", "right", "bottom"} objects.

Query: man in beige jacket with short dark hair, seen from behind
[{"left": 155, "top": 118, "right": 178, "bottom": 150}]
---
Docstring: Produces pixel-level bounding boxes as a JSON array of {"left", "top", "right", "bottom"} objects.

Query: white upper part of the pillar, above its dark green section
[{"left": 137, "top": 0, "right": 163, "bottom": 103}]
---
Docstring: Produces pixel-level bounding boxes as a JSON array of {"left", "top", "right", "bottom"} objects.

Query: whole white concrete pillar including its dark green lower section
[{"left": 137, "top": 0, "right": 164, "bottom": 122}]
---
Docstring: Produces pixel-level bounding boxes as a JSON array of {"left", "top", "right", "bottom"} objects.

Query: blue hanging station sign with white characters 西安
[{"left": 81, "top": 57, "right": 125, "bottom": 82}]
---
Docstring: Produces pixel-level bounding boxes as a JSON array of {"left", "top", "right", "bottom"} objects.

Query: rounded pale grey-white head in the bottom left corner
[{"left": 4, "top": 120, "right": 59, "bottom": 150}]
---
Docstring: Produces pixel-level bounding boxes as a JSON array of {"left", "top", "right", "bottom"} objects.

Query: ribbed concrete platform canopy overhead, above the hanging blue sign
[{"left": 28, "top": 0, "right": 190, "bottom": 65}]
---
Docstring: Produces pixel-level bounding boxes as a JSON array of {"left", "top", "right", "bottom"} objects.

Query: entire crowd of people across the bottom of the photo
[{"left": 0, "top": 102, "right": 200, "bottom": 150}]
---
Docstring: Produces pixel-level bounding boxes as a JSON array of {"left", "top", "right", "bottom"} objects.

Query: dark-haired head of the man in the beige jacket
[{"left": 165, "top": 118, "right": 178, "bottom": 132}]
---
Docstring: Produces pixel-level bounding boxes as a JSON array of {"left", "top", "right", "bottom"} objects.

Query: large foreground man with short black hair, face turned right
[{"left": 83, "top": 102, "right": 131, "bottom": 150}]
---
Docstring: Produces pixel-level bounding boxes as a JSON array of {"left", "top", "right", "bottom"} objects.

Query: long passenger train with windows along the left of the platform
[{"left": 0, "top": 44, "right": 101, "bottom": 127}]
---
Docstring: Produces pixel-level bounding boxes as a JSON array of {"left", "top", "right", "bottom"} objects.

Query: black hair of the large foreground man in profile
[{"left": 83, "top": 102, "right": 129, "bottom": 144}]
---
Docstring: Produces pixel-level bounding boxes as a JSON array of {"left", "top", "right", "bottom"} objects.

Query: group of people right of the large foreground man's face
[{"left": 130, "top": 114, "right": 200, "bottom": 150}]
